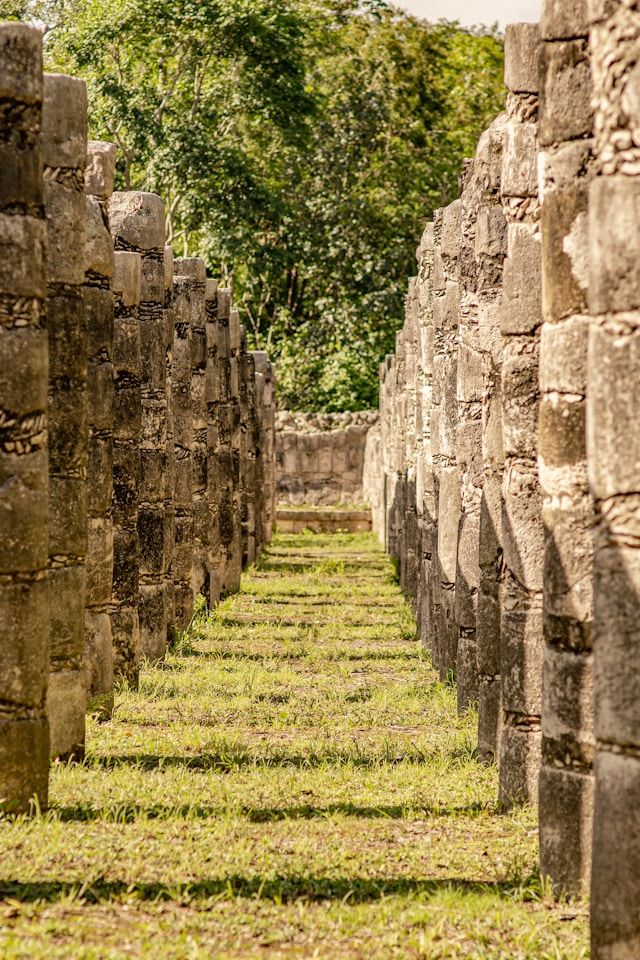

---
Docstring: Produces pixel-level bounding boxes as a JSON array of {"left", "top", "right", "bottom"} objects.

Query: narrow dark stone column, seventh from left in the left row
[{"left": 171, "top": 275, "right": 199, "bottom": 630}]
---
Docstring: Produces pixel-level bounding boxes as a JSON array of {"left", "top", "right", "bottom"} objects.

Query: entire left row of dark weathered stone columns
[{"left": 0, "top": 24, "right": 275, "bottom": 810}]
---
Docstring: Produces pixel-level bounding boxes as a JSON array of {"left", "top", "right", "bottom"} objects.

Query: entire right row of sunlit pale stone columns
[{"left": 374, "top": 0, "right": 640, "bottom": 960}]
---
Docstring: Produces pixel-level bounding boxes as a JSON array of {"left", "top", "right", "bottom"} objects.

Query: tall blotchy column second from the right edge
[{"left": 538, "top": 0, "right": 594, "bottom": 894}]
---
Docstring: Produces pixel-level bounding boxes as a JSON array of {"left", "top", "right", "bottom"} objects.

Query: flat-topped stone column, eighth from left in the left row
[{"left": 174, "top": 257, "right": 211, "bottom": 598}]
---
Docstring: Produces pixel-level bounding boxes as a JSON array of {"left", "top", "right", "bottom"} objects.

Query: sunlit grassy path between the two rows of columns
[{"left": 0, "top": 535, "right": 587, "bottom": 960}]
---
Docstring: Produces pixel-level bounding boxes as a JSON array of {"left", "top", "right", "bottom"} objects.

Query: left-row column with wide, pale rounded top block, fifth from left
[{"left": 109, "top": 192, "right": 171, "bottom": 672}]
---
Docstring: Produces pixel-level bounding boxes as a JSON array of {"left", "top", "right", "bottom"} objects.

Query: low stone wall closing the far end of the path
[{"left": 276, "top": 410, "right": 378, "bottom": 506}]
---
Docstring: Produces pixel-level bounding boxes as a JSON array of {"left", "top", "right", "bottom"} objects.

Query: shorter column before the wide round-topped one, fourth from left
[{"left": 111, "top": 250, "right": 142, "bottom": 684}]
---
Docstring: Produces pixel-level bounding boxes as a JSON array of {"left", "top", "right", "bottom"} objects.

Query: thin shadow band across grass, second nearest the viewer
[{"left": 48, "top": 803, "right": 493, "bottom": 823}]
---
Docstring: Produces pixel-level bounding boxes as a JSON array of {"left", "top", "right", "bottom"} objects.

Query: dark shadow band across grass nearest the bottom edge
[{"left": 0, "top": 874, "right": 538, "bottom": 904}]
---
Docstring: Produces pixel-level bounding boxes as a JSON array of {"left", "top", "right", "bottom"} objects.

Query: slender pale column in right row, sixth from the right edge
[{"left": 431, "top": 200, "right": 462, "bottom": 679}]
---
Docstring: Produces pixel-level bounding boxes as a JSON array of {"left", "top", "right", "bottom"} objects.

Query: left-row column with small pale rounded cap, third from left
[{"left": 83, "top": 140, "right": 116, "bottom": 719}]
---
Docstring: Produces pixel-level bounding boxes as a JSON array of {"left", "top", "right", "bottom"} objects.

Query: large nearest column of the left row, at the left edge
[{"left": 0, "top": 23, "right": 49, "bottom": 813}]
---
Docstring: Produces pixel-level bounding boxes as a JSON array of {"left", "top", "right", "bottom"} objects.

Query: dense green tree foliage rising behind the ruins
[{"left": 14, "top": 0, "right": 504, "bottom": 411}]
